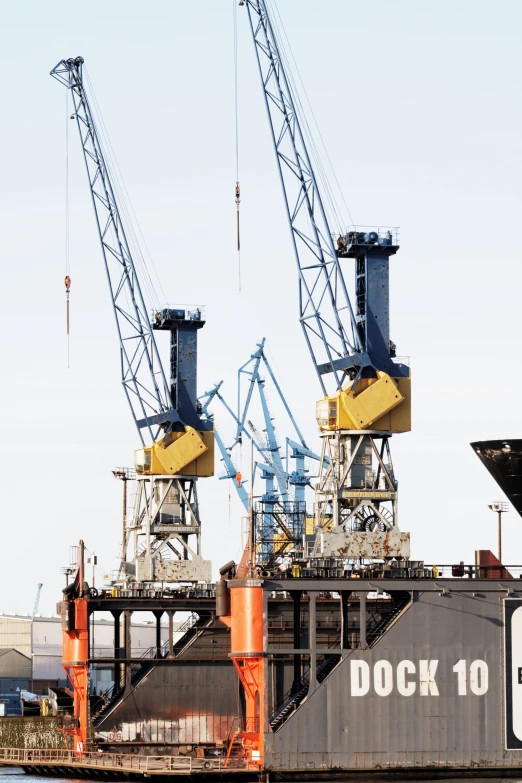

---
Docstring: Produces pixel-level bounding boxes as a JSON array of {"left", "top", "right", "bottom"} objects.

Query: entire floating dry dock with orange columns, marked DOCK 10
[{"left": 15, "top": 568, "right": 522, "bottom": 779}]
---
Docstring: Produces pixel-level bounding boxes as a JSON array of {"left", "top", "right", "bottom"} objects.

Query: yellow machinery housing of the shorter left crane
[{"left": 135, "top": 426, "right": 214, "bottom": 476}]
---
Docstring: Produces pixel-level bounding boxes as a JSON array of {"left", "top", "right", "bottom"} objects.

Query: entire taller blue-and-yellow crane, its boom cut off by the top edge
[{"left": 244, "top": 0, "right": 411, "bottom": 560}]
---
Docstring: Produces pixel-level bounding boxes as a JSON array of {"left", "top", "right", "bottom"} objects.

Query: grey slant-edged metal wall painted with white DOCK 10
[{"left": 267, "top": 591, "right": 522, "bottom": 769}]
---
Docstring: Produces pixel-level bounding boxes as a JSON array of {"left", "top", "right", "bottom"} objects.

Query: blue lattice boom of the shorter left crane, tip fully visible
[{"left": 51, "top": 57, "right": 180, "bottom": 445}]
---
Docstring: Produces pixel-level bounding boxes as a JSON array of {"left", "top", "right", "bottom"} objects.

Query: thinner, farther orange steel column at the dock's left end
[{"left": 62, "top": 598, "right": 89, "bottom": 753}]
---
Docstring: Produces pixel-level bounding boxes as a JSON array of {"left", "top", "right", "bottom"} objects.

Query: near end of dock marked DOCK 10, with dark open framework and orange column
[{"left": 216, "top": 572, "right": 522, "bottom": 775}]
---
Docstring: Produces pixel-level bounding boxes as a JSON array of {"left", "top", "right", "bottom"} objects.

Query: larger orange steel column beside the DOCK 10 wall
[{"left": 221, "top": 579, "right": 266, "bottom": 767}]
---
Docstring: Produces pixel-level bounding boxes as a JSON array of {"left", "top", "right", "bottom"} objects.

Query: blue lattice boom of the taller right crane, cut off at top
[{"left": 242, "top": 0, "right": 364, "bottom": 394}]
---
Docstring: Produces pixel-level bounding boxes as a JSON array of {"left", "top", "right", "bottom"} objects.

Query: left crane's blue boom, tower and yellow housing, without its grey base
[{"left": 51, "top": 57, "right": 214, "bottom": 484}]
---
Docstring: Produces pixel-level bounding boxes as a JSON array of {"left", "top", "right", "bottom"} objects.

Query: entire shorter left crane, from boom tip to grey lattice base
[{"left": 51, "top": 57, "right": 214, "bottom": 583}]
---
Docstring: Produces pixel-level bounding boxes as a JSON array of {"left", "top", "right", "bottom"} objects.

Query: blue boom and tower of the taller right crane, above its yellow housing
[{"left": 244, "top": 0, "right": 405, "bottom": 394}]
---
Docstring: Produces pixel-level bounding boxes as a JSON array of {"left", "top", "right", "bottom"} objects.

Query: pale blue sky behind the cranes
[{"left": 0, "top": 0, "right": 522, "bottom": 612}]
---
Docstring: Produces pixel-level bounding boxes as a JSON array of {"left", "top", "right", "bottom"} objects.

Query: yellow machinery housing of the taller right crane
[{"left": 317, "top": 371, "right": 411, "bottom": 432}]
